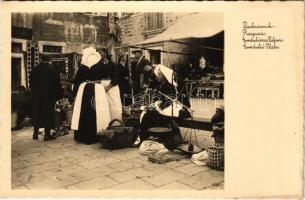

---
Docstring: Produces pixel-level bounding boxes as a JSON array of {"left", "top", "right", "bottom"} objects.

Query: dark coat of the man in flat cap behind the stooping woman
[{"left": 132, "top": 56, "right": 150, "bottom": 94}]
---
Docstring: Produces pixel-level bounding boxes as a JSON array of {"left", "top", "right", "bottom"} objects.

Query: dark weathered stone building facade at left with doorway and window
[{"left": 11, "top": 13, "right": 109, "bottom": 90}]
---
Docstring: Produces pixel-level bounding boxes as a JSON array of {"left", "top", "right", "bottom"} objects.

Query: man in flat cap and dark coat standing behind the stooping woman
[{"left": 132, "top": 49, "right": 150, "bottom": 95}]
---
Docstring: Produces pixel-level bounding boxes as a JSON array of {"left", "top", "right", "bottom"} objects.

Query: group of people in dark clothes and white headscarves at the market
[{"left": 30, "top": 47, "right": 189, "bottom": 144}]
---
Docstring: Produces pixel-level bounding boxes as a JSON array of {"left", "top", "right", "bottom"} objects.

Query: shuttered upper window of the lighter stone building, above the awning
[{"left": 145, "top": 13, "right": 164, "bottom": 31}]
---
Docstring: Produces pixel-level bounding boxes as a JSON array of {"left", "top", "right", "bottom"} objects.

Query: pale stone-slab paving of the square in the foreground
[{"left": 11, "top": 98, "right": 224, "bottom": 190}]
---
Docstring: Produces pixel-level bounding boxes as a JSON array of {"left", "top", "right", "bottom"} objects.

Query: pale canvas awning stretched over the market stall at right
[{"left": 135, "top": 13, "right": 224, "bottom": 46}]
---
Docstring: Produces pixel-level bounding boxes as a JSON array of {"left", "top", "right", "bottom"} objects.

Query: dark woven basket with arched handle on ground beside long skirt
[{"left": 97, "top": 119, "right": 137, "bottom": 149}]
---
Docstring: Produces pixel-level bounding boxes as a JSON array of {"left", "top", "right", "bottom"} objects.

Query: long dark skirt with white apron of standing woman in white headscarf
[{"left": 71, "top": 80, "right": 122, "bottom": 144}]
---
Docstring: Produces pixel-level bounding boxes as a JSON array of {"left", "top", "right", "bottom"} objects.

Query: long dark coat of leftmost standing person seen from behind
[{"left": 30, "top": 62, "right": 62, "bottom": 128}]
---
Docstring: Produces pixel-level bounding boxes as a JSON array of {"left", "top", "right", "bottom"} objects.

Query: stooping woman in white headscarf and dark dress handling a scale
[{"left": 140, "top": 65, "right": 182, "bottom": 141}]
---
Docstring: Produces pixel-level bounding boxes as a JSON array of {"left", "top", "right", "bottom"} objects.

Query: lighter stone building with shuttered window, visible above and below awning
[{"left": 118, "top": 12, "right": 224, "bottom": 72}]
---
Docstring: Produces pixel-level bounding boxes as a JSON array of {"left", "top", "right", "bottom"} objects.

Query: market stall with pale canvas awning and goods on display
[{"left": 129, "top": 13, "right": 224, "bottom": 97}]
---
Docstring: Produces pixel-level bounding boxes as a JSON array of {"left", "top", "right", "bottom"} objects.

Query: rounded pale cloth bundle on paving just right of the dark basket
[{"left": 139, "top": 140, "right": 168, "bottom": 155}]
